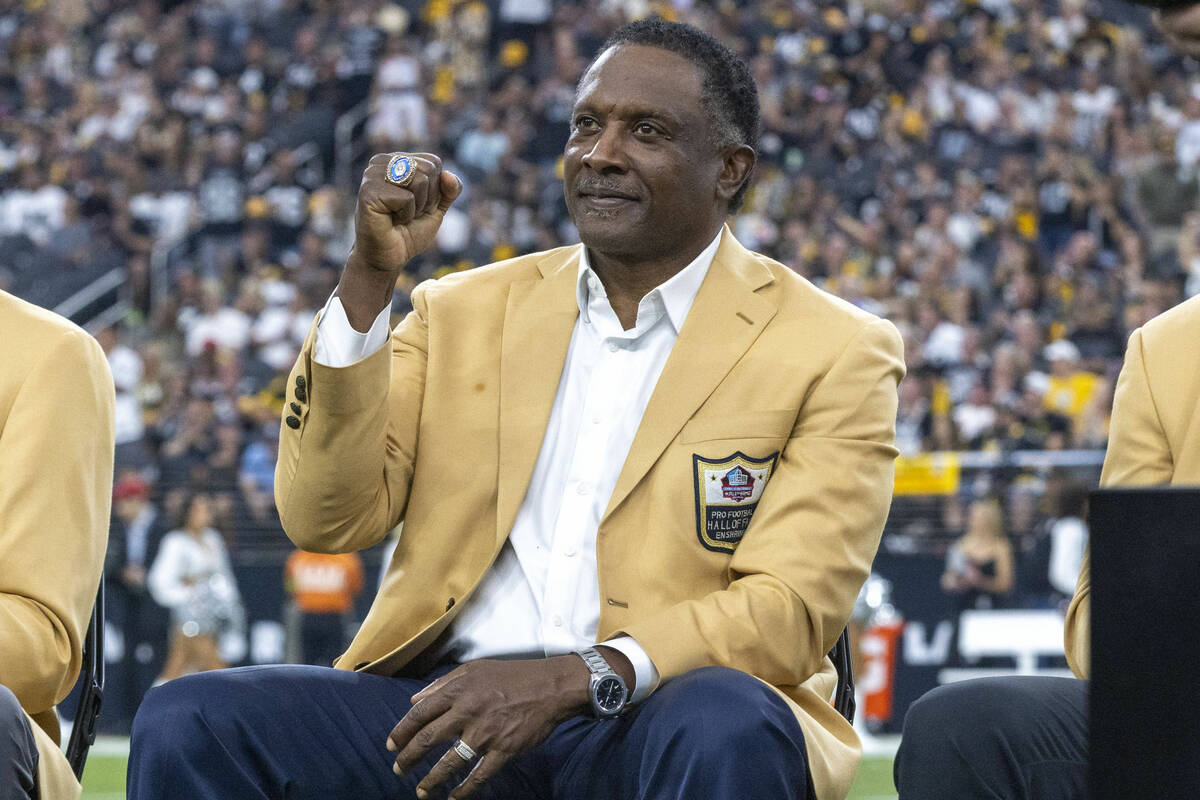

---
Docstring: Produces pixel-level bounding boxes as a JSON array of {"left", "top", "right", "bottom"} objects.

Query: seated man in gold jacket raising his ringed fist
[{"left": 130, "top": 20, "right": 904, "bottom": 800}]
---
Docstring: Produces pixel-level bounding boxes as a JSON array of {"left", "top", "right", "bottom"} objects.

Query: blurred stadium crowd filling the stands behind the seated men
[{"left": 0, "top": 0, "right": 1200, "bottom": 724}]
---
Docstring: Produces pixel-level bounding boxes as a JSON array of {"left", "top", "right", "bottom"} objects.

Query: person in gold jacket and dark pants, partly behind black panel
[{"left": 895, "top": 296, "right": 1200, "bottom": 800}]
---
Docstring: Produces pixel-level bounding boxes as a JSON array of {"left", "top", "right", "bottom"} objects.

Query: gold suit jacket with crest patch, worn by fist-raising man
[{"left": 275, "top": 228, "right": 904, "bottom": 798}]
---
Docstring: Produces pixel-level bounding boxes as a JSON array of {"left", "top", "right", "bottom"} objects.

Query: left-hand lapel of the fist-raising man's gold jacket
[{"left": 496, "top": 247, "right": 580, "bottom": 545}]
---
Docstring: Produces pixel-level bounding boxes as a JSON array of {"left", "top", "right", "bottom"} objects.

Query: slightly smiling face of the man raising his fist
[{"left": 564, "top": 44, "right": 752, "bottom": 263}]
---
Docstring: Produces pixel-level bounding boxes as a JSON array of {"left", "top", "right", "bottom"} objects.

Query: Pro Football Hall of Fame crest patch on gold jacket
[{"left": 691, "top": 451, "right": 779, "bottom": 553}]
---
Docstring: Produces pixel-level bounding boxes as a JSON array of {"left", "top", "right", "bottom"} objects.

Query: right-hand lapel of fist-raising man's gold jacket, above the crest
[{"left": 601, "top": 227, "right": 776, "bottom": 522}]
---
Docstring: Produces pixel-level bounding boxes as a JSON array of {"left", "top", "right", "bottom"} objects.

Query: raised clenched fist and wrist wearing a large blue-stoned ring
[{"left": 337, "top": 152, "right": 462, "bottom": 331}]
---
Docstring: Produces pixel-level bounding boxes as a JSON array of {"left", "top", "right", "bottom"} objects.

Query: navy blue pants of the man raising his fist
[{"left": 127, "top": 667, "right": 815, "bottom": 800}]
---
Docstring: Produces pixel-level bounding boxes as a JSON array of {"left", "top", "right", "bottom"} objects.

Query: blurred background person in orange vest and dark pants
[{"left": 283, "top": 549, "right": 362, "bottom": 667}]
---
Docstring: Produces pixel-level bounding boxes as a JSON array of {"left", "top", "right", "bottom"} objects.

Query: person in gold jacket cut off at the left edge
[{"left": 0, "top": 291, "right": 115, "bottom": 800}]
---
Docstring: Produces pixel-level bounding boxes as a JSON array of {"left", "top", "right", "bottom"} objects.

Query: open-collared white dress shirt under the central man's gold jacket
[{"left": 313, "top": 234, "right": 720, "bottom": 702}]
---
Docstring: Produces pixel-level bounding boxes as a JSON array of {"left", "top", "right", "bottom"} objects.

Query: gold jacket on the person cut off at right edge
[{"left": 1066, "top": 296, "right": 1200, "bottom": 678}]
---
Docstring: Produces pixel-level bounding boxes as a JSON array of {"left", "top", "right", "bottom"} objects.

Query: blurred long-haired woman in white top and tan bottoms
[{"left": 146, "top": 493, "right": 242, "bottom": 682}]
